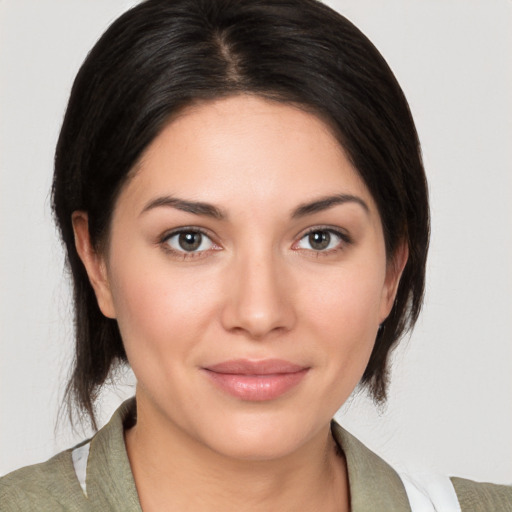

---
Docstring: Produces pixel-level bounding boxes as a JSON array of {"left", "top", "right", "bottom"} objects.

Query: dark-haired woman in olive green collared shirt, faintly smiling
[{"left": 1, "top": 0, "right": 512, "bottom": 511}]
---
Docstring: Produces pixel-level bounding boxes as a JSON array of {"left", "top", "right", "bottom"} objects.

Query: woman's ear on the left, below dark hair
[{"left": 71, "top": 211, "right": 116, "bottom": 318}]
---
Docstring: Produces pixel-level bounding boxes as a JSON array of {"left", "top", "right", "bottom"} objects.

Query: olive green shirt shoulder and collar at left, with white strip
[{"left": 0, "top": 400, "right": 141, "bottom": 512}]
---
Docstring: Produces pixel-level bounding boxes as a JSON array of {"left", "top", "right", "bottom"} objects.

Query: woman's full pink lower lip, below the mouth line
[{"left": 204, "top": 368, "right": 308, "bottom": 402}]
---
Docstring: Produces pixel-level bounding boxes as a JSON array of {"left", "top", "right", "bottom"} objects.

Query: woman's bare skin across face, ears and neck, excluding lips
[{"left": 73, "top": 95, "right": 407, "bottom": 512}]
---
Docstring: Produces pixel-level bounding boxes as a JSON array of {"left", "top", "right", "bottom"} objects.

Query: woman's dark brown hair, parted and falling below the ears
[{"left": 53, "top": 0, "right": 429, "bottom": 424}]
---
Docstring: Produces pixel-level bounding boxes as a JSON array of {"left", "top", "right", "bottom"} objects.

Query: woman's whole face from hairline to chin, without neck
[{"left": 79, "top": 95, "right": 400, "bottom": 459}]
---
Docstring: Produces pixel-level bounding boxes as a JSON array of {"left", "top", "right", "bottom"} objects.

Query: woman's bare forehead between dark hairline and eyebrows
[{"left": 120, "top": 95, "right": 373, "bottom": 216}]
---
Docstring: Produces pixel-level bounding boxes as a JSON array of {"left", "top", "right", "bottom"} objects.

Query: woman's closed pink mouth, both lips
[{"left": 202, "top": 359, "right": 310, "bottom": 402}]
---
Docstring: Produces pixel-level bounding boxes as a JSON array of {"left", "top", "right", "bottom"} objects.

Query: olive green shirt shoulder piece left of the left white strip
[{"left": 0, "top": 450, "right": 86, "bottom": 512}]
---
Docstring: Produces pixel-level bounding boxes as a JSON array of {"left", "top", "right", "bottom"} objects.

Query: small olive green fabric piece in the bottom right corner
[{"left": 451, "top": 477, "right": 512, "bottom": 512}]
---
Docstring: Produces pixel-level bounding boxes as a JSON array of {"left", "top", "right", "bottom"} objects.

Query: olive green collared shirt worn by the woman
[{"left": 0, "top": 399, "right": 512, "bottom": 512}]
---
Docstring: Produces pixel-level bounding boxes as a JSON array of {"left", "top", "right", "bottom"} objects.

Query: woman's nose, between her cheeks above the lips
[{"left": 222, "top": 254, "right": 296, "bottom": 340}]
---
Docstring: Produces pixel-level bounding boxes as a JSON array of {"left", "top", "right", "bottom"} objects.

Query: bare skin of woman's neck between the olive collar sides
[{"left": 125, "top": 396, "right": 350, "bottom": 512}]
